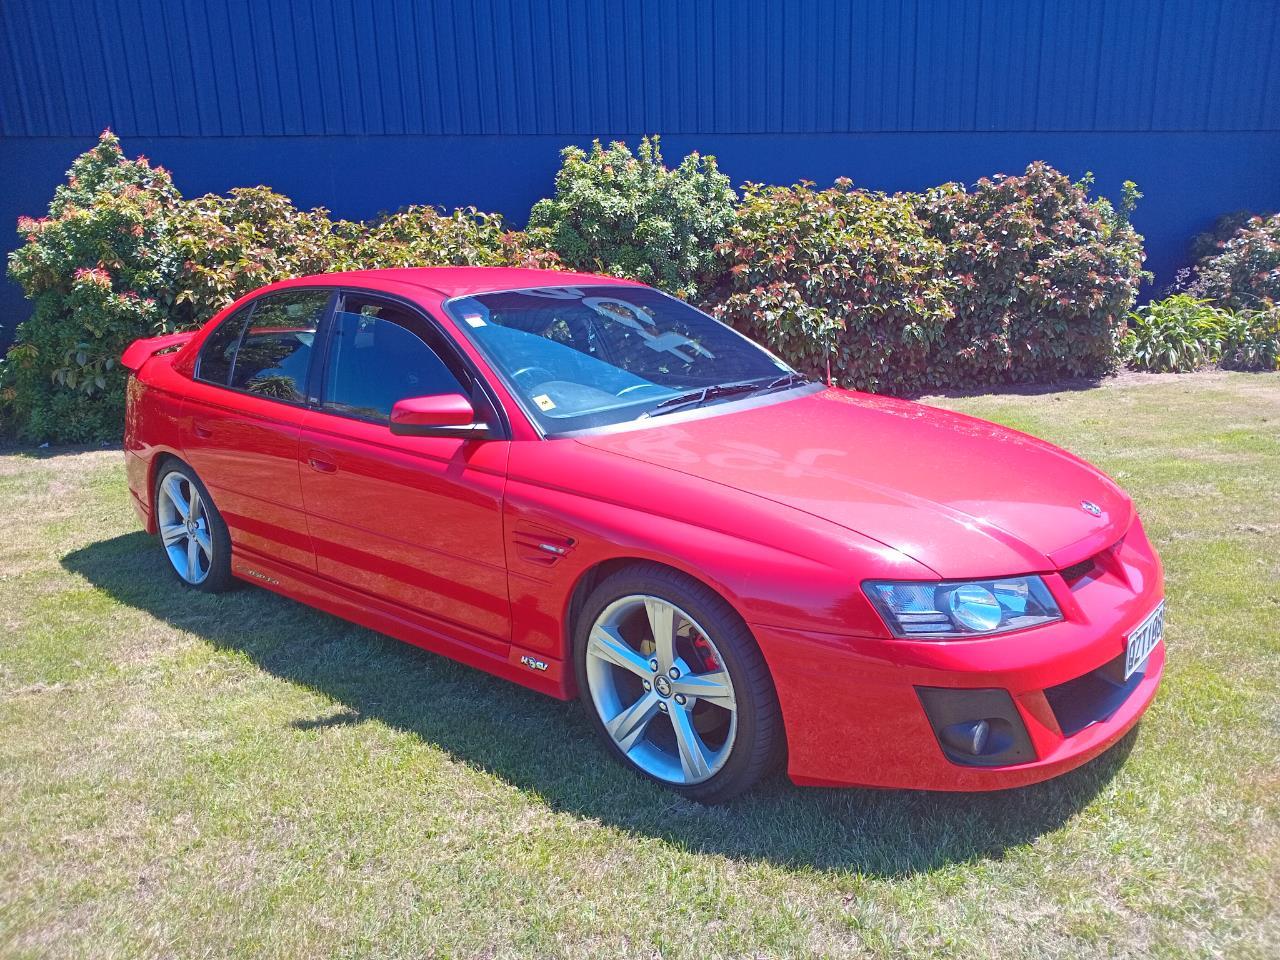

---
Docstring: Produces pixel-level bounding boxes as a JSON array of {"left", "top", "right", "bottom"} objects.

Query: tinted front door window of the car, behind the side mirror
[{"left": 324, "top": 303, "right": 467, "bottom": 420}]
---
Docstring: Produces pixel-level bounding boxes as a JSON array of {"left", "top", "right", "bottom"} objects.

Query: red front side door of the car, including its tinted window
[{"left": 301, "top": 292, "right": 511, "bottom": 653}]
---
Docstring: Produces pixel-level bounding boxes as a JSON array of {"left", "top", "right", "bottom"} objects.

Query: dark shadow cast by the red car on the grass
[{"left": 63, "top": 531, "right": 1137, "bottom": 877}]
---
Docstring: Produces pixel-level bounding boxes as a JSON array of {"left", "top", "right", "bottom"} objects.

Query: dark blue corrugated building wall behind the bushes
[{"left": 0, "top": 0, "right": 1280, "bottom": 340}]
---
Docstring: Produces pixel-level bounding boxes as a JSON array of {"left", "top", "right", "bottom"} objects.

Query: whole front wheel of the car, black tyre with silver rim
[{"left": 573, "top": 563, "right": 783, "bottom": 804}]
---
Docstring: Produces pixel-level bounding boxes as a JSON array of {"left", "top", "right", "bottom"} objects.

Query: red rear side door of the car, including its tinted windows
[{"left": 182, "top": 287, "right": 334, "bottom": 570}]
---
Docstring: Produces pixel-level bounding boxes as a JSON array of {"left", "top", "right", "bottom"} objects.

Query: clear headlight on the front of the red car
[{"left": 863, "top": 577, "right": 1062, "bottom": 639}]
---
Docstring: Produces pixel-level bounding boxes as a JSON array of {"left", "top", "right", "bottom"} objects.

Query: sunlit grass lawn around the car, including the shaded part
[{"left": 0, "top": 374, "right": 1280, "bottom": 957}]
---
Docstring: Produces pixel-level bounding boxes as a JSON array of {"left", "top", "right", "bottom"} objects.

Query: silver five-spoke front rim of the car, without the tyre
[{"left": 586, "top": 594, "right": 737, "bottom": 785}]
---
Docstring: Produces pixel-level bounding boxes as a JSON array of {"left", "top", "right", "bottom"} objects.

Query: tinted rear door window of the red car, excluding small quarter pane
[{"left": 230, "top": 291, "right": 329, "bottom": 403}]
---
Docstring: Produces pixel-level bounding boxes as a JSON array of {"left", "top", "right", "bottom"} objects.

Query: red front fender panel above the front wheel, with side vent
[{"left": 494, "top": 439, "right": 931, "bottom": 695}]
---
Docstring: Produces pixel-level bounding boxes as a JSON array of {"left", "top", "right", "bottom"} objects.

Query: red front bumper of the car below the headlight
[{"left": 753, "top": 524, "right": 1165, "bottom": 791}]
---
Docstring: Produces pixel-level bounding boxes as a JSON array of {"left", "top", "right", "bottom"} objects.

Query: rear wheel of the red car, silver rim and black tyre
[{"left": 152, "top": 461, "right": 234, "bottom": 594}]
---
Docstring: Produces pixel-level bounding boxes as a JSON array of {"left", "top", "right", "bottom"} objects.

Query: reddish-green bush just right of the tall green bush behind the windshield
[{"left": 714, "top": 180, "right": 951, "bottom": 393}]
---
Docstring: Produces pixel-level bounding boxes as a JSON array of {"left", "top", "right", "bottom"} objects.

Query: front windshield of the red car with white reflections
[{"left": 447, "top": 285, "right": 804, "bottom": 434}]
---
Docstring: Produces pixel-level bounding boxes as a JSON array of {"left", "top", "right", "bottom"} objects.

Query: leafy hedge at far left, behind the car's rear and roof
[{"left": 0, "top": 132, "right": 558, "bottom": 442}]
